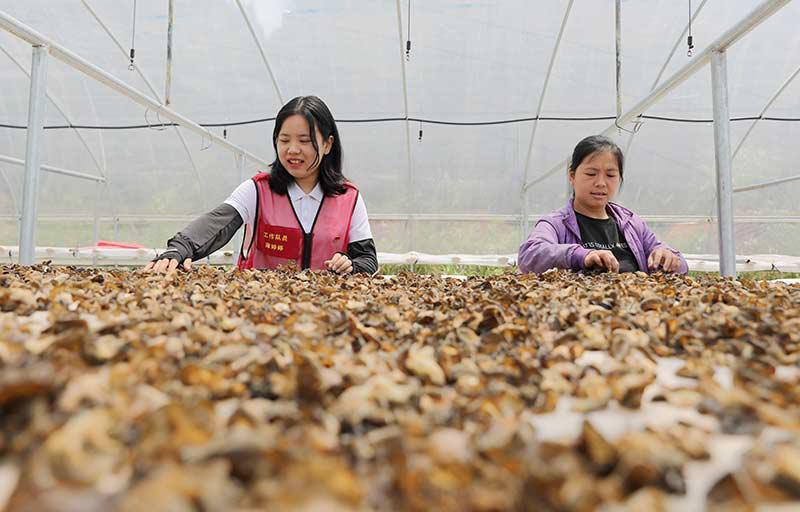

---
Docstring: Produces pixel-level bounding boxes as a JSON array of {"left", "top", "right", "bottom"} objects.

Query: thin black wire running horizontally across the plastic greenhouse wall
[{"left": 0, "top": 115, "right": 800, "bottom": 130}]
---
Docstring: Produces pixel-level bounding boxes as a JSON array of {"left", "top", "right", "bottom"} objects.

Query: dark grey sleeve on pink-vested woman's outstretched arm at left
[{"left": 159, "top": 203, "right": 242, "bottom": 261}]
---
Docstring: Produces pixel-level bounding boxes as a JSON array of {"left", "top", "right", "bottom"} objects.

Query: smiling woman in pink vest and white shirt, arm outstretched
[{"left": 145, "top": 96, "right": 378, "bottom": 274}]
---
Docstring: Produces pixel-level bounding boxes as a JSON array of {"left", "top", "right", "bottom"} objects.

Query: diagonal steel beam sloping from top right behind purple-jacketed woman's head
[{"left": 524, "top": 0, "right": 791, "bottom": 190}]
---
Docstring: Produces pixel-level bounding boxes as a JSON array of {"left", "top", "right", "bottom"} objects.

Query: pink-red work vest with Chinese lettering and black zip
[{"left": 239, "top": 173, "right": 358, "bottom": 270}]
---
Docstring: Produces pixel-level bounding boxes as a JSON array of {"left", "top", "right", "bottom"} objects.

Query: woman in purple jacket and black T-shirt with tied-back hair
[{"left": 518, "top": 135, "right": 689, "bottom": 274}]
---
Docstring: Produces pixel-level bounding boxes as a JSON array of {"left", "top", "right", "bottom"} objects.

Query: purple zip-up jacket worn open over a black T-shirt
[{"left": 517, "top": 199, "right": 689, "bottom": 274}]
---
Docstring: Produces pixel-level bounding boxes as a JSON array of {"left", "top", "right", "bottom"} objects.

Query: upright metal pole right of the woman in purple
[{"left": 711, "top": 50, "right": 736, "bottom": 277}]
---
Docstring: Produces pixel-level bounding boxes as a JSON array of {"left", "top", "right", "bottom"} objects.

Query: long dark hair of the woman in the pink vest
[{"left": 269, "top": 96, "right": 347, "bottom": 196}]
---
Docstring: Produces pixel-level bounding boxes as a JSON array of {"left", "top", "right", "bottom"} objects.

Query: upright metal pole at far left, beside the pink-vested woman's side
[{"left": 19, "top": 45, "right": 48, "bottom": 265}]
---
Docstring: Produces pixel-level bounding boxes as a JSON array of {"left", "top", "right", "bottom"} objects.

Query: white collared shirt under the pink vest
[{"left": 225, "top": 180, "right": 372, "bottom": 245}]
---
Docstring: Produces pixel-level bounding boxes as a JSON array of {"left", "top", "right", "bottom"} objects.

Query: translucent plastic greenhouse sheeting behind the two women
[{"left": 0, "top": 0, "right": 800, "bottom": 254}]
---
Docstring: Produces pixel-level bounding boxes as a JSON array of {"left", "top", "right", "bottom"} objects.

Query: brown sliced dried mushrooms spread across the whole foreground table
[{"left": 0, "top": 265, "right": 800, "bottom": 511}]
